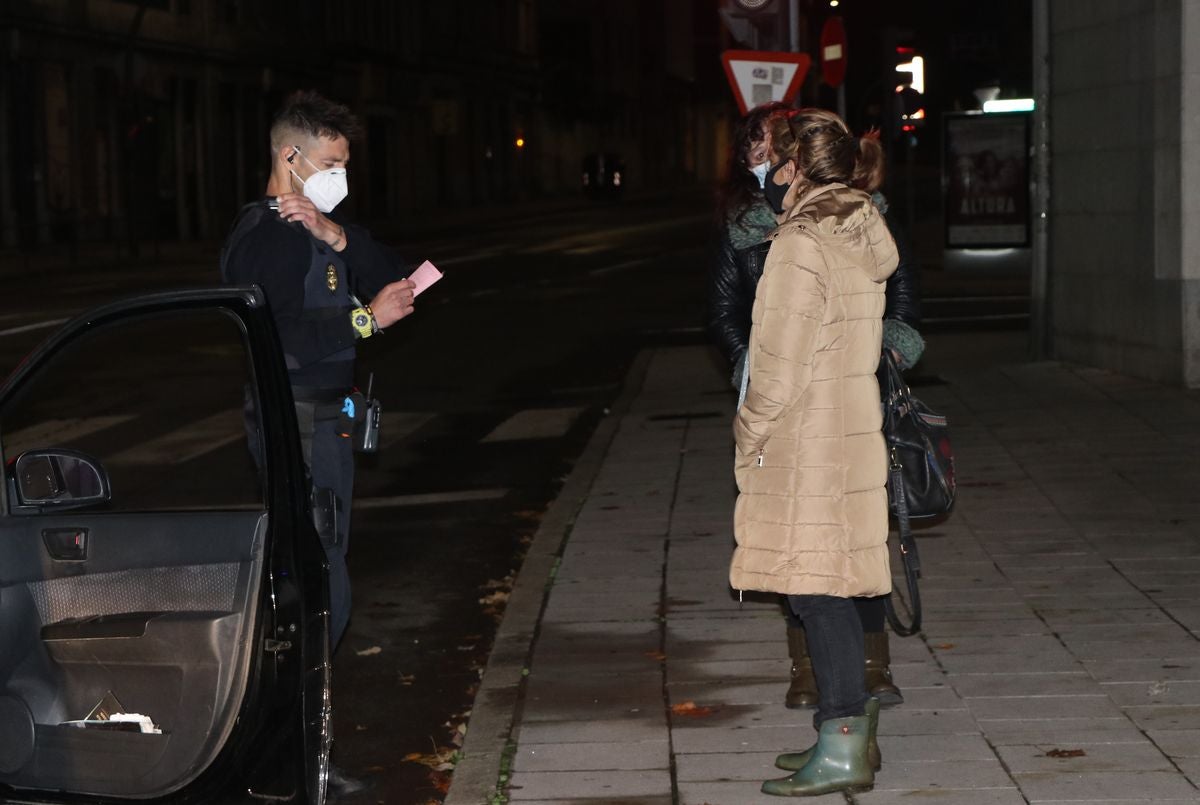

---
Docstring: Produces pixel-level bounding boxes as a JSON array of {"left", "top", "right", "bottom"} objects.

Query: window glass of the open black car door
[{"left": 0, "top": 310, "right": 263, "bottom": 511}]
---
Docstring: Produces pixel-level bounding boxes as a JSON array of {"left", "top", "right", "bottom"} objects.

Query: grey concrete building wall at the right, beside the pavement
[{"left": 1045, "top": 0, "right": 1200, "bottom": 388}]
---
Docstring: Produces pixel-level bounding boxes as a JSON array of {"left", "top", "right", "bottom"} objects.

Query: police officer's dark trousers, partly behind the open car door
[{"left": 296, "top": 403, "right": 354, "bottom": 648}]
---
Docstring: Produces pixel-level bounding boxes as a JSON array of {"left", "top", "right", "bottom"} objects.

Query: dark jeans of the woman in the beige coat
[{"left": 787, "top": 595, "right": 866, "bottom": 726}]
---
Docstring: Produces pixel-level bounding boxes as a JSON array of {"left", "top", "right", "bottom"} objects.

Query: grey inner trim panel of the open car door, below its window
[{"left": 0, "top": 512, "right": 266, "bottom": 797}]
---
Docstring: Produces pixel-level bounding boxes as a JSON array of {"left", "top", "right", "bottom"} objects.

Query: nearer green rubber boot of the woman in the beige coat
[{"left": 762, "top": 715, "right": 875, "bottom": 797}]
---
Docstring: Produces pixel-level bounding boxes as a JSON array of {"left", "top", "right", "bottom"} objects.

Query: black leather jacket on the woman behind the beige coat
[{"left": 707, "top": 210, "right": 920, "bottom": 370}]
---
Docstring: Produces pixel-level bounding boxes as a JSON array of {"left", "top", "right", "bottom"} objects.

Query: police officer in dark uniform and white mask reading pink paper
[{"left": 221, "top": 91, "right": 413, "bottom": 647}]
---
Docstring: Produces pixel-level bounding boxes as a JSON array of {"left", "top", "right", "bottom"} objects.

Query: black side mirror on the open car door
[{"left": 10, "top": 447, "right": 113, "bottom": 511}]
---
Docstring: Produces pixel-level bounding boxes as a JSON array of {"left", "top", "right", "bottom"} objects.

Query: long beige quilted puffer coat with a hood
[{"left": 730, "top": 185, "right": 896, "bottom": 597}]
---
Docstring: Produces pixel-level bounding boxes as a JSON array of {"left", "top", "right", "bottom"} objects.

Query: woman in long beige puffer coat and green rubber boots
[{"left": 730, "top": 109, "right": 896, "bottom": 795}]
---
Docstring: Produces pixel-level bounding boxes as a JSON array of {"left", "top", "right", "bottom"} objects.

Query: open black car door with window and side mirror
[{"left": 0, "top": 288, "right": 330, "bottom": 805}]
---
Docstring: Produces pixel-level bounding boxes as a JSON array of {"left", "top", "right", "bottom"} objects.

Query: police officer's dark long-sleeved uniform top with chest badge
[{"left": 221, "top": 199, "right": 408, "bottom": 402}]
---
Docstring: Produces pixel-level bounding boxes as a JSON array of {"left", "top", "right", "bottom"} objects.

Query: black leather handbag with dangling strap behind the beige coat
[{"left": 880, "top": 350, "right": 956, "bottom": 637}]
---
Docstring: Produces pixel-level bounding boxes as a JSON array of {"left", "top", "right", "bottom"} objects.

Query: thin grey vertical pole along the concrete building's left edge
[{"left": 1030, "top": 0, "right": 1050, "bottom": 360}]
